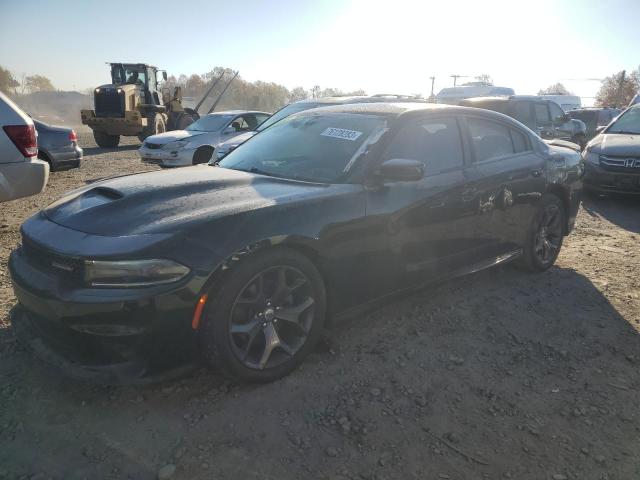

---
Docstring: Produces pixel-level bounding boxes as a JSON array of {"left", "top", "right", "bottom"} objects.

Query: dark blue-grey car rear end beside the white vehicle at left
[{"left": 33, "top": 119, "right": 82, "bottom": 170}]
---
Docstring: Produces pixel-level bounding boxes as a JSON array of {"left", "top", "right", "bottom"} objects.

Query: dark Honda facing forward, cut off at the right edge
[{"left": 583, "top": 105, "right": 640, "bottom": 195}]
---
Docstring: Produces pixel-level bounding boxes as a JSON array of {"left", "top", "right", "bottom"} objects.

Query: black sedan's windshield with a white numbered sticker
[{"left": 219, "top": 112, "right": 386, "bottom": 183}]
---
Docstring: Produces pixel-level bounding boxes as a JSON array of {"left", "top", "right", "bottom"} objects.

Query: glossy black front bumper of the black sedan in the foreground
[{"left": 9, "top": 242, "right": 201, "bottom": 384}]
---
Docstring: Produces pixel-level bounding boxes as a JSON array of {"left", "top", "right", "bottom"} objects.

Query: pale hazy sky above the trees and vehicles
[{"left": 0, "top": 0, "right": 640, "bottom": 103}]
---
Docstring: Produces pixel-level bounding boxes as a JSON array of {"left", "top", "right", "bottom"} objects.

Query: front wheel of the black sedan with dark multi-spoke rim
[{"left": 199, "top": 247, "right": 326, "bottom": 383}]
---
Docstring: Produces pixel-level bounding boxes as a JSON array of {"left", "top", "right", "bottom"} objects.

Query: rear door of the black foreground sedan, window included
[{"left": 466, "top": 116, "right": 545, "bottom": 257}]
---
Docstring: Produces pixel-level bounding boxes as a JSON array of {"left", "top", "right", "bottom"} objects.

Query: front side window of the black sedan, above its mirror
[{"left": 384, "top": 118, "right": 464, "bottom": 175}]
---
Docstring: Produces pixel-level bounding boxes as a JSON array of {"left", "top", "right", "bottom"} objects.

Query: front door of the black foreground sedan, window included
[{"left": 367, "top": 116, "right": 477, "bottom": 285}]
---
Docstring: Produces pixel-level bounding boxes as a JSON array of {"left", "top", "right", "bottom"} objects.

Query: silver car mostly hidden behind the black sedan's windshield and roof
[{"left": 214, "top": 93, "right": 426, "bottom": 161}]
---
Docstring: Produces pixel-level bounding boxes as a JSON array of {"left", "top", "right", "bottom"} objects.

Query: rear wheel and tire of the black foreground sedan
[{"left": 517, "top": 193, "right": 567, "bottom": 272}]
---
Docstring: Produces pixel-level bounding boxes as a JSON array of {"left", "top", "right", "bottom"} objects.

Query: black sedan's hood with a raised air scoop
[{"left": 44, "top": 165, "right": 332, "bottom": 236}]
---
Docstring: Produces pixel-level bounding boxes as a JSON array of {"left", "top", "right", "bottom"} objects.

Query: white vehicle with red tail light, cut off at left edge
[{"left": 0, "top": 92, "right": 49, "bottom": 202}]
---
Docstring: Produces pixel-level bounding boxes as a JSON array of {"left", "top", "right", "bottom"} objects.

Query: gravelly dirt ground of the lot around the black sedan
[{"left": 0, "top": 134, "right": 640, "bottom": 480}]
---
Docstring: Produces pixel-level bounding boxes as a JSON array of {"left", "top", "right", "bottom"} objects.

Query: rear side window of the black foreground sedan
[{"left": 467, "top": 118, "right": 530, "bottom": 162}]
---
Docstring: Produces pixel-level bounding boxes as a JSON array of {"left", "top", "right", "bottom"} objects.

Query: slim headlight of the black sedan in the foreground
[{"left": 84, "top": 259, "right": 189, "bottom": 288}]
